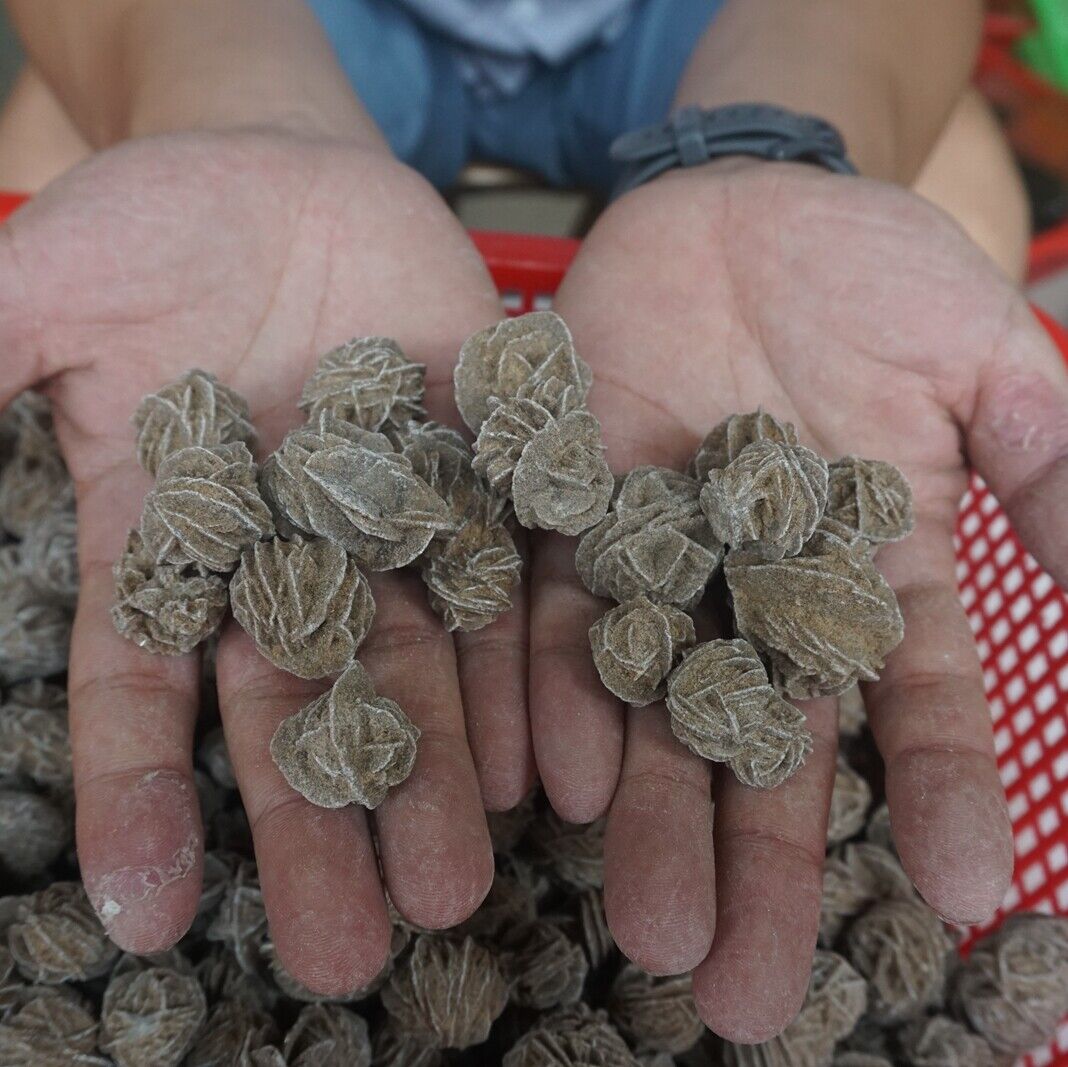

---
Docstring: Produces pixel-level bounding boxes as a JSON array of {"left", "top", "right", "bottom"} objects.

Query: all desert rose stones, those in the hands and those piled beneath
[{"left": 0, "top": 313, "right": 1068, "bottom": 1067}]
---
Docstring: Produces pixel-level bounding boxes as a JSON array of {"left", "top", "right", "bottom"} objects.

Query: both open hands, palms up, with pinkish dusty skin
[{"left": 0, "top": 135, "right": 1068, "bottom": 1040}]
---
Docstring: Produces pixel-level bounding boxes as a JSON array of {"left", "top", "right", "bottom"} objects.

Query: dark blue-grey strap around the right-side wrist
[{"left": 609, "top": 104, "right": 857, "bottom": 195}]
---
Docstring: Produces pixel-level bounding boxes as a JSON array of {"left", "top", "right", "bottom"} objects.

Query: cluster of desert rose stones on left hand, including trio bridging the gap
[{"left": 112, "top": 312, "right": 613, "bottom": 807}]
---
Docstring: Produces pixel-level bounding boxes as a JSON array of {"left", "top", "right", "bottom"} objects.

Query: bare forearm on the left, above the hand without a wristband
[{"left": 9, "top": 0, "right": 383, "bottom": 147}]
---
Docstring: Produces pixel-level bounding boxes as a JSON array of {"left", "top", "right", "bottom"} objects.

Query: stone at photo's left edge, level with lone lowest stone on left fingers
[{"left": 0, "top": 680, "right": 74, "bottom": 788}]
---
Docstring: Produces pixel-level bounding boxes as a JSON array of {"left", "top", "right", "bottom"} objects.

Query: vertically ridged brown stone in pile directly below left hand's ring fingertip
[{"left": 382, "top": 933, "right": 508, "bottom": 1049}]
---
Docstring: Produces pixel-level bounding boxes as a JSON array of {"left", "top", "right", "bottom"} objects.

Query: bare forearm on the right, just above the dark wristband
[{"left": 676, "top": 0, "right": 981, "bottom": 183}]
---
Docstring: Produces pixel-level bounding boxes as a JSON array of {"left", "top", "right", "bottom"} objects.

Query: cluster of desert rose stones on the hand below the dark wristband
[{"left": 576, "top": 410, "right": 913, "bottom": 788}]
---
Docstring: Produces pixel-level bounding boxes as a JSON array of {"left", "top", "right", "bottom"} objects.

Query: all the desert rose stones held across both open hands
[{"left": 114, "top": 312, "right": 912, "bottom": 807}]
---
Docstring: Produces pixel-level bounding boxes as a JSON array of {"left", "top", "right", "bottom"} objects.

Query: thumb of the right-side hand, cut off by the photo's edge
[{"left": 967, "top": 300, "right": 1068, "bottom": 587}]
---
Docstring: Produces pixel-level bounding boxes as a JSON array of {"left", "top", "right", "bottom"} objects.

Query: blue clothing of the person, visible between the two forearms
[{"left": 307, "top": 0, "right": 722, "bottom": 189}]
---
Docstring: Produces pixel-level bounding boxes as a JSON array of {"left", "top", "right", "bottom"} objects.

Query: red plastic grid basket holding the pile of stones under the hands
[{"left": 0, "top": 193, "right": 1068, "bottom": 1067}]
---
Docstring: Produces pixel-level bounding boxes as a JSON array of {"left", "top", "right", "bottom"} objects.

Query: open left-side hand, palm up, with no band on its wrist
[{"left": 0, "top": 132, "right": 533, "bottom": 993}]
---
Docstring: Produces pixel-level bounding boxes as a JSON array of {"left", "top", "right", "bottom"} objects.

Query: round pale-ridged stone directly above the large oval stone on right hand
[{"left": 701, "top": 440, "right": 827, "bottom": 560}]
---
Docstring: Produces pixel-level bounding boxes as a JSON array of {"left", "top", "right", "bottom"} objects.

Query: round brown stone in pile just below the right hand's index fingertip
[{"left": 846, "top": 900, "right": 953, "bottom": 1023}]
